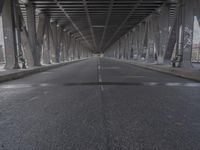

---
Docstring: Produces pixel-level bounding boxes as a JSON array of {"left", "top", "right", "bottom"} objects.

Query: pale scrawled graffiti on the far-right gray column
[{"left": 184, "top": 27, "right": 193, "bottom": 49}]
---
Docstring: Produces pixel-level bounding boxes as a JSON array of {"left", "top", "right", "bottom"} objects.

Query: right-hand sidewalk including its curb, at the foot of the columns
[{"left": 112, "top": 58, "right": 200, "bottom": 82}]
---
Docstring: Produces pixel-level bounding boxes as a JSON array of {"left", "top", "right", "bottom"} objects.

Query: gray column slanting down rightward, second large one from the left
[{"left": 26, "top": 2, "right": 41, "bottom": 66}]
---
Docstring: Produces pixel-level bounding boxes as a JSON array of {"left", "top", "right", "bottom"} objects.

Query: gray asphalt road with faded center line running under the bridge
[{"left": 0, "top": 58, "right": 200, "bottom": 150}]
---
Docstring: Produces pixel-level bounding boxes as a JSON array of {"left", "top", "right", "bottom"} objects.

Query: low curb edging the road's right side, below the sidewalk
[{"left": 109, "top": 58, "right": 200, "bottom": 82}]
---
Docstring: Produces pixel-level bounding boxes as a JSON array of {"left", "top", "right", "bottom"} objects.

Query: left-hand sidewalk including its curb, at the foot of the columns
[{"left": 0, "top": 58, "right": 87, "bottom": 83}]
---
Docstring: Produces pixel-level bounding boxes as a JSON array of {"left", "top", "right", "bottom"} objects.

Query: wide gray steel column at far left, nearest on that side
[{"left": 2, "top": 0, "right": 20, "bottom": 69}]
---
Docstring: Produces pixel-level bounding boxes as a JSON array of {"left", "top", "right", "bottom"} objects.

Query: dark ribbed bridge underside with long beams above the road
[{"left": 20, "top": 0, "right": 175, "bottom": 51}]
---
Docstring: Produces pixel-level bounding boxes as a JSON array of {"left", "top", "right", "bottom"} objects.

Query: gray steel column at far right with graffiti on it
[{"left": 181, "top": 0, "right": 194, "bottom": 68}]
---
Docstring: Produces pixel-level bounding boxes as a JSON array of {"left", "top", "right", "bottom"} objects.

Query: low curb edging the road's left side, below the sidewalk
[{"left": 0, "top": 58, "right": 87, "bottom": 83}]
